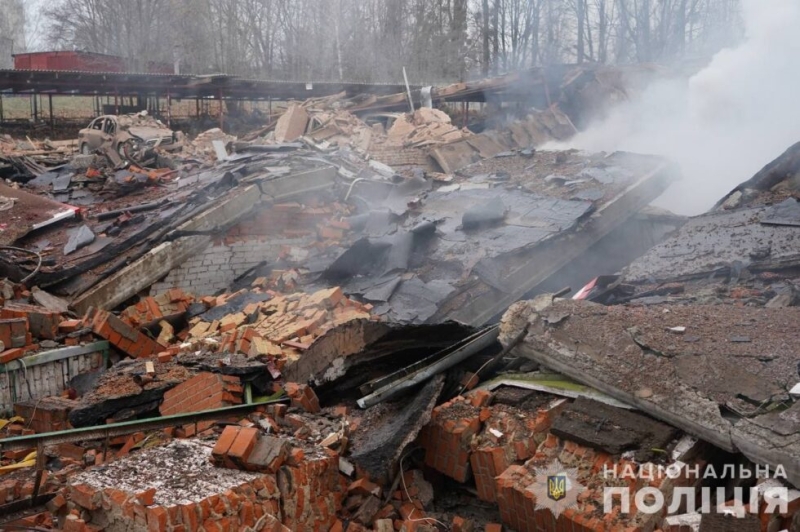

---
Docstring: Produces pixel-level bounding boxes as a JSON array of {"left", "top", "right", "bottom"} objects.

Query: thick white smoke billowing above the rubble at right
[{"left": 570, "top": 0, "right": 800, "bottom": 214}]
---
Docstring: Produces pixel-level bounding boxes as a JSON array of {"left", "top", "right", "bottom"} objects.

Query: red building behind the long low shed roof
[{"left": 14, "top": 52, "right": 173, "bottom": 74}]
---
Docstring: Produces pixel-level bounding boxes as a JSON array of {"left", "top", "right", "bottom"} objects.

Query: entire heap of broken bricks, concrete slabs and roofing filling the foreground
[{"left": 0, "top": 68, "right": 800, "bottom": 532}]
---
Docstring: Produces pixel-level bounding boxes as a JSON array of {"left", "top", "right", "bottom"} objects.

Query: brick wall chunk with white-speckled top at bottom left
[{"left": 65, "top": 440, "right": 344, "bottom": 532}]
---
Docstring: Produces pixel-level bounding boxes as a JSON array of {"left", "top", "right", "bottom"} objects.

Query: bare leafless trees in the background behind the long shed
[{"left": 45, "top": 0, "right": 742, "bottom": 83}]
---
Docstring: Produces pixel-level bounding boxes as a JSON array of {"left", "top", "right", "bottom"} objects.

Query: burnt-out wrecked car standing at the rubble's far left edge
[{"left": 78, "top": 112, "right": 183, "bottom": 164}]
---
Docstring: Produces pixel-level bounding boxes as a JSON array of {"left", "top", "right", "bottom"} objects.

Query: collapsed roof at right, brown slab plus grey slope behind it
[{"left": 501, "top": 140, "right": 800, "bottom": 485}]
